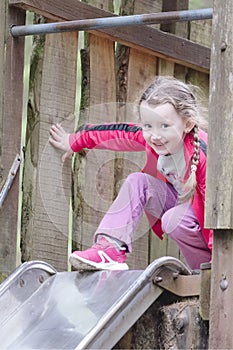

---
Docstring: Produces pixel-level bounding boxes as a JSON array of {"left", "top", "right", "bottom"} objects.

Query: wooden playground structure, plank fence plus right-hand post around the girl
[{"left": 0, "top": 0, "right": 233, "bottom": 349}]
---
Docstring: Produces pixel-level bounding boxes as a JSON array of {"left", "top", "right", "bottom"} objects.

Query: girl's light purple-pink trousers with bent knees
[{"left": 94, "top": 172, "right": 211, "bottom": 269}]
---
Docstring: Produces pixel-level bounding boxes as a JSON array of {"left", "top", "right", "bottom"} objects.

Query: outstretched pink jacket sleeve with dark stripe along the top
[{"left": 69, "top": 123, "right": 146, "bottom": 152}]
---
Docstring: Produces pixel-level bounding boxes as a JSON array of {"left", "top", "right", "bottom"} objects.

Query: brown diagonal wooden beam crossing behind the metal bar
[{"left": 9, "top": 0, "right": 210, "bottom": 72}]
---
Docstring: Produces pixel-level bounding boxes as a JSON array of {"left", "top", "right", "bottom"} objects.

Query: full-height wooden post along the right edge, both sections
[{"left": 205, "top": 0, "right": 233, "bottom": 349}]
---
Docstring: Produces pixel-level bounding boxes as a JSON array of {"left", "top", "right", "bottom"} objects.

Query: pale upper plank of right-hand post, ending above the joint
[{"left": 205, "top": 1, "right": 233, "bottom": 229}]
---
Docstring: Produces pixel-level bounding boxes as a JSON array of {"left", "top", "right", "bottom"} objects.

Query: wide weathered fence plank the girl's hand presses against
[{"left": 38, "top": 33, "right": 78, "bottom": 270}]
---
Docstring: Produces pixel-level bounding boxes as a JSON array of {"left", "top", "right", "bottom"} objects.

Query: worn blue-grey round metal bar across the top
[{"left": 10, "top": 8, "right": 213, "bottom": 37}]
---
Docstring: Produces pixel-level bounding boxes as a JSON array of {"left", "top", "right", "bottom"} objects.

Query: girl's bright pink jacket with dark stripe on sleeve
[{"left": 69, "top": 123, "right": 212, "bottom": 249}]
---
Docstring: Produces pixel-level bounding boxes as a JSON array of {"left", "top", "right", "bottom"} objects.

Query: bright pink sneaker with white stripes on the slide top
[{"left": 69, "top": 238, "right": 129, "bottom": 270}]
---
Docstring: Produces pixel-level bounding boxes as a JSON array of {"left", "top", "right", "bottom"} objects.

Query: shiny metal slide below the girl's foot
[{"left": 0, "top": 257, "right": 191, "bottom": 350}]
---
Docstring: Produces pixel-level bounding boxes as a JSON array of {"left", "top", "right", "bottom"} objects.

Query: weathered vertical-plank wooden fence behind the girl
[{"left": 0, "top": 0, "right": 211, "bottom": 277}]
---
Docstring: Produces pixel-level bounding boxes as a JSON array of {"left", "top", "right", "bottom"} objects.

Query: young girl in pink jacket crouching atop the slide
[{"left": 49, "top": 77, "right": 212, "bottom": 270}]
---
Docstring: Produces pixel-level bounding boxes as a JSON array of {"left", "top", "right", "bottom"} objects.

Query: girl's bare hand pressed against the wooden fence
[{"left": 49, "top": 124, "right": 73, "bottom": 162}]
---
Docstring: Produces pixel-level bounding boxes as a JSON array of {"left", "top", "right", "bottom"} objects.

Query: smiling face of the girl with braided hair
[{"left": 140, "top": 101, "right": 194, "bottom": 155}]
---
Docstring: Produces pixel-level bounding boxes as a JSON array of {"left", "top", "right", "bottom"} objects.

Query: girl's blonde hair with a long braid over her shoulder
[{"left": 139, "top": 76, "right": 207, "bottom": 202}]
